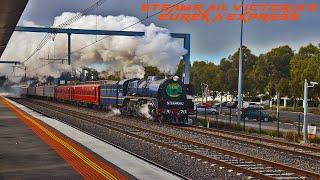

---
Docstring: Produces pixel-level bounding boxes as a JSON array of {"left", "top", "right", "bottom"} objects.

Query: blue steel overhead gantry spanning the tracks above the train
[{"left": 15, "top": 26, "right": 191, "bottom": 84}]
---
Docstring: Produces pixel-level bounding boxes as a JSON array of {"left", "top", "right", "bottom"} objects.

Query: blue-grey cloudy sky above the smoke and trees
[{"left": 8, "top": 0, "right": 320, "bottom": 63}]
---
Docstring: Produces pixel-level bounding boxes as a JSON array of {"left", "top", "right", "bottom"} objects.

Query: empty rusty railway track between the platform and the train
[{"left": 13, "top": 97, "right": 320, "bottom": 179}]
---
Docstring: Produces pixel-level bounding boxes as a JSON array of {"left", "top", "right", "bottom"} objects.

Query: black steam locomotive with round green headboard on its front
[{"left": 122, "top": 76, "right": 193, "bottom": 124}]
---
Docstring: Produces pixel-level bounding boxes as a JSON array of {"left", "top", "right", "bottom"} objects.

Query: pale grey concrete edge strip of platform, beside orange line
[{"left": 1, "top": 97, "right": 180, "bottom": 180}]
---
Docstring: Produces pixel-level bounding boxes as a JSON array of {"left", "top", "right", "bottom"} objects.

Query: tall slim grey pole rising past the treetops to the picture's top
[{"left": 237, "top": 0, "right": 244, "bottom": 124}]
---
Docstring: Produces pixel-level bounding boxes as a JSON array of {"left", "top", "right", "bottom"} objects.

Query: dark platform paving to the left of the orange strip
[{"left": 0, "top": 100, "right": 81, "bottom": 179}]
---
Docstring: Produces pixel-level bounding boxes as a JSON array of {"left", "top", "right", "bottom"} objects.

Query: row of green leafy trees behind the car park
[{"left": 176, "top": 44, "right": 320, "bottom": 106}]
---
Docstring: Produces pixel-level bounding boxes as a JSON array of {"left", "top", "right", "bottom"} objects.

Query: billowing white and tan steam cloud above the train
[{"left": 0, "top": 12, "right": 186, "bottom": 78}]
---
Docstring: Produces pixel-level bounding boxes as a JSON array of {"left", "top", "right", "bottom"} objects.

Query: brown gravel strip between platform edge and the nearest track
[{"left": 11, "top": 100, "right": 248, "bottom": 179}]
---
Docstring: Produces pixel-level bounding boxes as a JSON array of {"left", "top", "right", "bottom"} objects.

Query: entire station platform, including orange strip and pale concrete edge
[{"left": 0, "top": 96, "right": 179, "bottom": 179}]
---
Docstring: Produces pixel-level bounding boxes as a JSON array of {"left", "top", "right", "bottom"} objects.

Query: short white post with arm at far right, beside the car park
[{"left": 303, "top": 80, "right": 318, "bottom": 142}]
